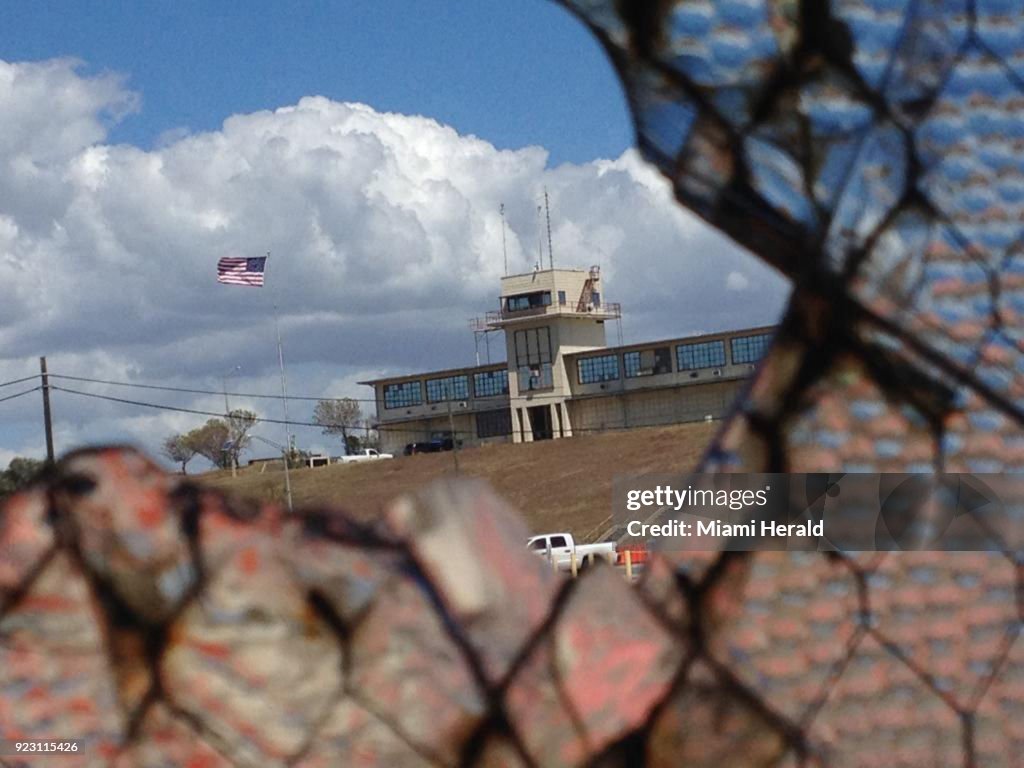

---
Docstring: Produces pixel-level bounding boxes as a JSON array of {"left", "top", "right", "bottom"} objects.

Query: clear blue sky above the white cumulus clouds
[{"left": 0, "top": 0, "right": 633, "bottom": 164}]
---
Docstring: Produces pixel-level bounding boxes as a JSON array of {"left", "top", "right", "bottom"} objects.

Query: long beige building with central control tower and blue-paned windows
[{"left": 360, "top": 267, "right": 773, "bottom": 453}]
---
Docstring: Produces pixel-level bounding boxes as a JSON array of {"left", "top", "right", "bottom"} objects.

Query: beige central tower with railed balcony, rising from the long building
[{"left": 477, "top": 266, "right": 622, "bottom": 442}]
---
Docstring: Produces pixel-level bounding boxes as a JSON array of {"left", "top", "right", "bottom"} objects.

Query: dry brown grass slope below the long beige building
[{"left": 198, "top": 423, "right": 717, "bottom": 540}]
